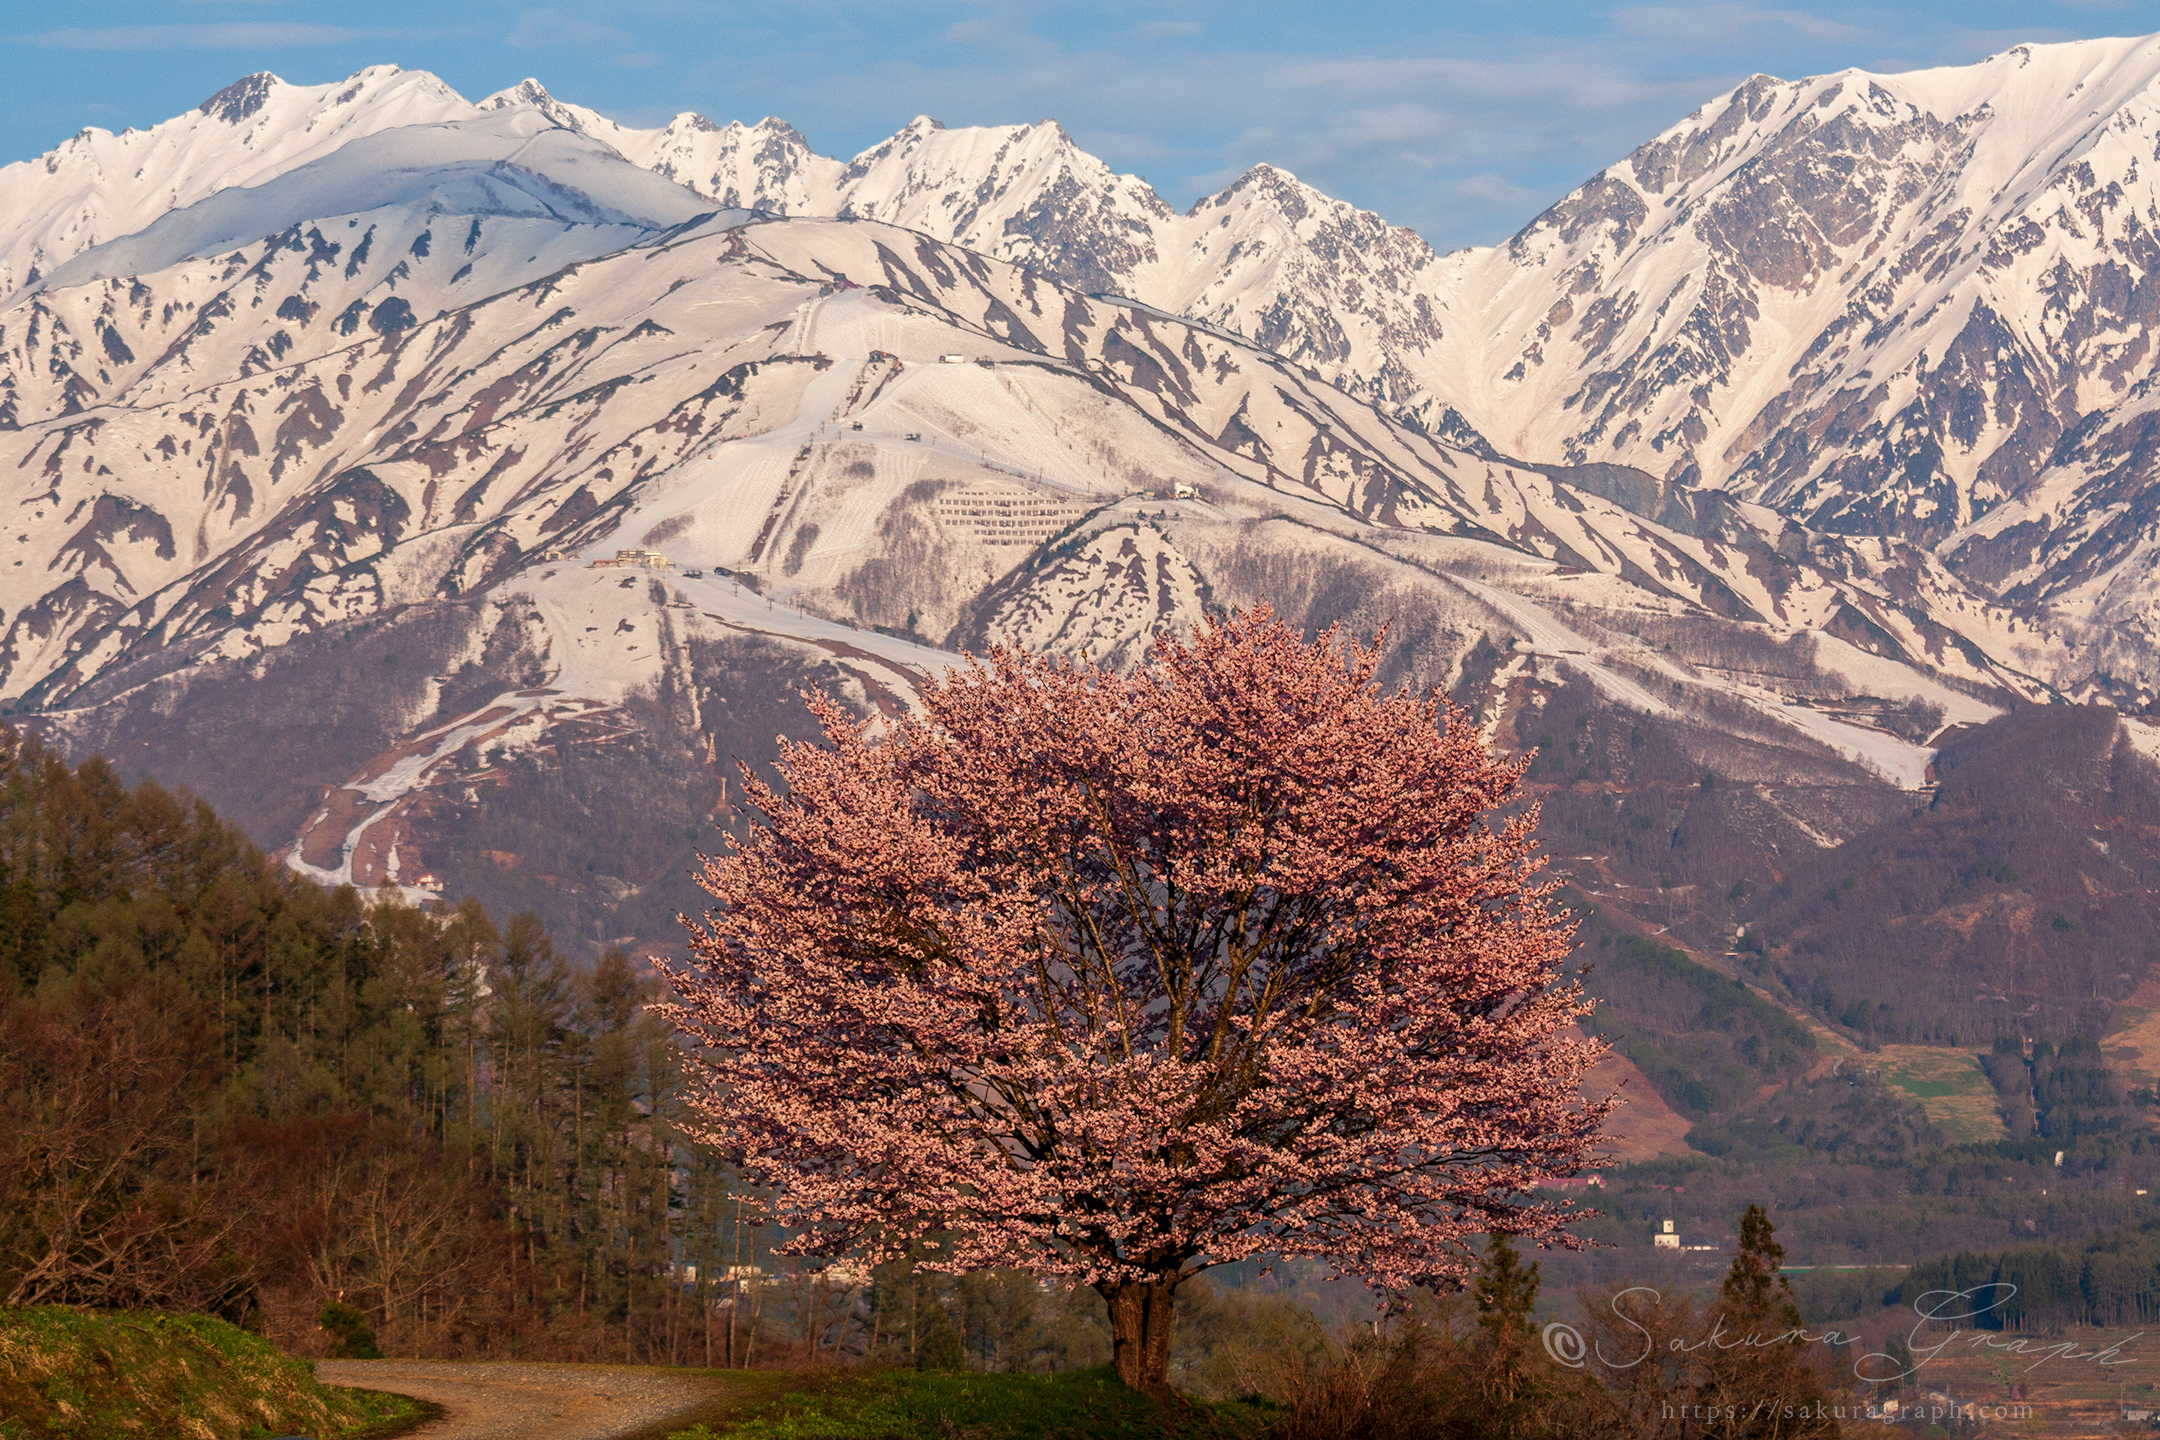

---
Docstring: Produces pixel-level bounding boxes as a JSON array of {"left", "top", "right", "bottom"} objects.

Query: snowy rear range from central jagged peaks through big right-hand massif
[{"left": 464, "top": 39, "right": 2160, "bottom": 704}]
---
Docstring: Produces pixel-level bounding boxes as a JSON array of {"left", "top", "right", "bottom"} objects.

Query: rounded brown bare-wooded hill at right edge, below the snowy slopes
[{"left": 1739, "top": 706, "right": 2160, "bottom": 1049}]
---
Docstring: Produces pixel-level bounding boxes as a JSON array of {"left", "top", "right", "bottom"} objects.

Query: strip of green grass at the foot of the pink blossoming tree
[{"left": 648, "top": 1369, "right": 1270, "bottom": 1440}]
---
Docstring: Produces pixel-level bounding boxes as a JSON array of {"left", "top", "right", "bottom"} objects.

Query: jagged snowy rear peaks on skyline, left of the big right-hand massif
[{"left": 0, "top": 65, "right": 1462, "bottom": 434}]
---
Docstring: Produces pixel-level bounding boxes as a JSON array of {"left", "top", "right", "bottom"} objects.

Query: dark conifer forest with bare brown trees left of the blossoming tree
[{"left": 0, "top": 730, "right": 725, "bottom": 1358}]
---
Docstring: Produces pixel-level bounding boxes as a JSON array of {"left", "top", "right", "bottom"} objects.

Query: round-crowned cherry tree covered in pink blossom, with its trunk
[{"left": 670, "top": 609, "right": 1611, "bottom": 1397}]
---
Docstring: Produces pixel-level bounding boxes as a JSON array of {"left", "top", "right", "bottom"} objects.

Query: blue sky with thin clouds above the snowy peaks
[{"left": 0, "top": 0, "right": 2160, "bottom": 250}]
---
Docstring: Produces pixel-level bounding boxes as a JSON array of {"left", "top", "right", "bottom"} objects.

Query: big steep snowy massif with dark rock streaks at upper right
[{"left": 1428, "top": 37, "right": 2160, "bottom": 699}]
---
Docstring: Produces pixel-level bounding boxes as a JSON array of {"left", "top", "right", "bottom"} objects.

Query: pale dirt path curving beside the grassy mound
[{"left": 315, "top": 1360, "right": 721, "bottom": 1440}]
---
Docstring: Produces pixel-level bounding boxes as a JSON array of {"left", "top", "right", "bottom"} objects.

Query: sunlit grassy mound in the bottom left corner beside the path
[{"left": 0, "top": 1306, "right": 426, "bottom": 1440}]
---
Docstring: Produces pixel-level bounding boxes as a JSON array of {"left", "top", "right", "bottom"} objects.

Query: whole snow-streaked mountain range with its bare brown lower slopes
[{"left": 21, "top": 41, "right": 2160, "bottom": 1122}]
